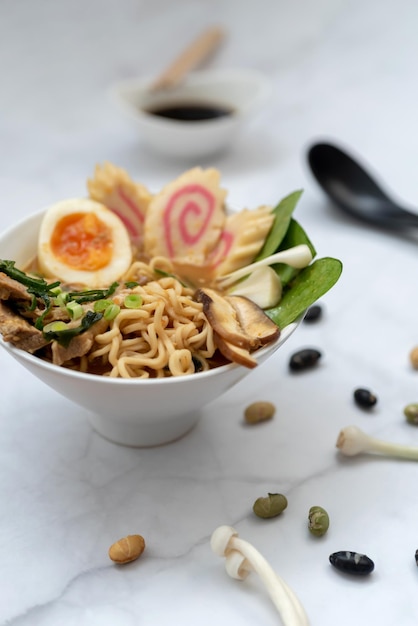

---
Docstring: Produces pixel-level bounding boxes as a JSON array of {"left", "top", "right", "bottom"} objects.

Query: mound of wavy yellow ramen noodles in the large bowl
[{"left": 84, "top": 263, "right": 216, "bottom": 378}]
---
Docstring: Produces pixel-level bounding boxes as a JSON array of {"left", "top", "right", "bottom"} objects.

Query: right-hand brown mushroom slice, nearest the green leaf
[{"left": 225, "top": 296, "right": 280, "bottom": 346}]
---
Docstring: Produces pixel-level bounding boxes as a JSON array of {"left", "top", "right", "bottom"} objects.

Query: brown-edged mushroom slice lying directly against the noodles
[{"left": 195, "top": 288, "right": 253, "bottom": 350}]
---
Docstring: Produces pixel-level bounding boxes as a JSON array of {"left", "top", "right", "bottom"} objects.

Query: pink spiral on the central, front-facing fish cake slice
[{"left": 163, "top": 184, "right": 215, "bottom": 258}]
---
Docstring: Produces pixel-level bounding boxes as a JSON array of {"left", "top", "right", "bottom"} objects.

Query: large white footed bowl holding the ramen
[{"left": 0, "top": 211, "right": 300, "bottom": 446}]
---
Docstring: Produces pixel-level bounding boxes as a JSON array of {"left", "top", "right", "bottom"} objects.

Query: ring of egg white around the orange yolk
[{"left": 38, "top": 198, "right": 132, "bottom": 289}]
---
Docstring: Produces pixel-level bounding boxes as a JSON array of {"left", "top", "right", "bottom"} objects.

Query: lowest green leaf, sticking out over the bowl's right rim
[{"left": 266, "top": 257, "right": 342, "bottom": 328}]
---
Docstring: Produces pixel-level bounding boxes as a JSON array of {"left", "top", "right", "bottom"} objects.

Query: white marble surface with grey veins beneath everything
[{"left": 0, "top": 0, "right": 418, "bottom": 626}]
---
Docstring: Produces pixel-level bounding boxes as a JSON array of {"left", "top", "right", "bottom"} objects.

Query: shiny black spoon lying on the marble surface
[{"left": 308, "top": 143, "right": 418, "bottom": 230}]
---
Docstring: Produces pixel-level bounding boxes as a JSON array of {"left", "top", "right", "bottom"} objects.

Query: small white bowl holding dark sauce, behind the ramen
[{"left": 112, "top": 70, "right": 271, "bottom": 158}]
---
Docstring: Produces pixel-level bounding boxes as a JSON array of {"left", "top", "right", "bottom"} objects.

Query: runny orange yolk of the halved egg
[{"left": 51, "top": 213, "right": 113, "bottom": 272}]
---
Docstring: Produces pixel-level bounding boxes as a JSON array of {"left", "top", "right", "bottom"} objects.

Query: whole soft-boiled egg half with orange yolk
[{"left": 38, "top": 198, "right": 132, "bottom": 289}]
